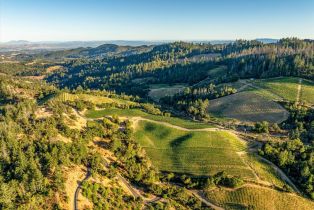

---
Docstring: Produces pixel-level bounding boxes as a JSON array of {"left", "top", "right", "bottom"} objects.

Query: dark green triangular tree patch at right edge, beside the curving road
[{"left": 259, "top": 139, "right": 314, "bottom": 199}]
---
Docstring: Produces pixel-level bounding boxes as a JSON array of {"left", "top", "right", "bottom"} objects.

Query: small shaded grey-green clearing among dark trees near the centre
[{"left": 148, "top": 84, "right": 186, "bottom": 101}]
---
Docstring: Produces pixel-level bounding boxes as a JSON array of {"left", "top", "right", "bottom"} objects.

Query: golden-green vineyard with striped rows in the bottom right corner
[{"left": 206, "top": 185, "right": 314, "bottom": 210}]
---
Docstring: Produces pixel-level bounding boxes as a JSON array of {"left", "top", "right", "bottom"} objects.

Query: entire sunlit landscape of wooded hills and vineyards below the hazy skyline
[{"left": 0, "top": 38, "right": 314, "bottom": 210}]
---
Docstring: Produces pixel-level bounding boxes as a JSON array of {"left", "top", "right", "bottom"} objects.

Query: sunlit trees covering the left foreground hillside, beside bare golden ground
[{"left": 0, "top": 76, "right": 119, "bottom": 209}]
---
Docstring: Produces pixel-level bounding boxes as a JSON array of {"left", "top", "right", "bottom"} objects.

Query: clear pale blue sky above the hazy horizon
[{"left": 0, "top": 0, "right": 314, "bottom": 42}]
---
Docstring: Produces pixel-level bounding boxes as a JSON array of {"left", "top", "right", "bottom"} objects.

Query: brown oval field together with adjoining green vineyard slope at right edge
[{"left": 208, "top": 77, "right": 314, "bottom": 123}]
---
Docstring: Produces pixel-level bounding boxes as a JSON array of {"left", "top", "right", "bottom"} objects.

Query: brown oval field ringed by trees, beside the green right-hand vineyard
[{"left": 208, "top": 92, "right": 288, "bottom": 123}]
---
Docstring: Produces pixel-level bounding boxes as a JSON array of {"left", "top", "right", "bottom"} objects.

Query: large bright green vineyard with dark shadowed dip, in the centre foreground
[{"left": 134, "top": 121, "right": 254, "bottom": 179}]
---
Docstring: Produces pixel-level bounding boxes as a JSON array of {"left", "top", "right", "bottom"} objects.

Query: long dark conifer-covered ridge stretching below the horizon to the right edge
[{"left": 48, "top": 38, "right": 314, "bottom": 95}]
